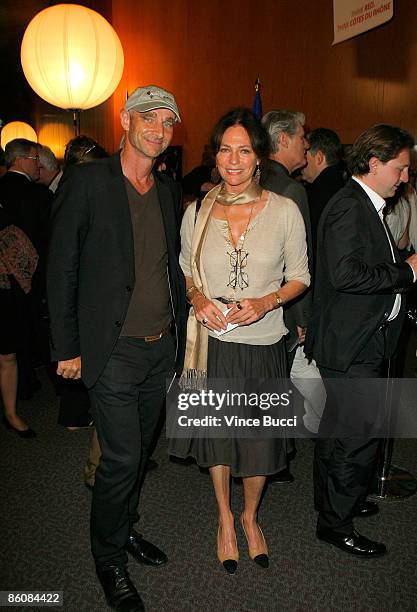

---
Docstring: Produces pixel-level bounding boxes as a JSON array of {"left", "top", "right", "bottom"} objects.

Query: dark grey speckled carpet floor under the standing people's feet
[{"left": 0, "top": 368, "right": 417, "bottom": 612}]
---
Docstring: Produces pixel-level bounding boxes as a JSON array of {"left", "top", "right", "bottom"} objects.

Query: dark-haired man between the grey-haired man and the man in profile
[{"left": 301, "top": 128, "right": 346, "bottom": 261}]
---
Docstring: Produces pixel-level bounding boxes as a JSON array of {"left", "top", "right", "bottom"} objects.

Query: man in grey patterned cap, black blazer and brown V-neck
[{"left": 48, "top": 85, "right": 186, "bottom": 611}]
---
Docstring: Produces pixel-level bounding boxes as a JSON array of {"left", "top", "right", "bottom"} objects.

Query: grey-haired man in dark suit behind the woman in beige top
[{"left": 261, "top": 110, "right": 311, "bottom": 484}]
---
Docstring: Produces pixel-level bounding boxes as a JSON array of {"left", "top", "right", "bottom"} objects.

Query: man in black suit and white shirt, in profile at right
[{"left": 305, "top": 125, "right": 417, "bottom": 557}]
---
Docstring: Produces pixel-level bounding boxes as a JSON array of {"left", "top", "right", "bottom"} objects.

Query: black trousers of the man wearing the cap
[{"left": 90, "top": 334, "right": 175, "bottom": 568}]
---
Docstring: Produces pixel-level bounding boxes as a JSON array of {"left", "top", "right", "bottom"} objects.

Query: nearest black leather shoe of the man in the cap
[{"left": 97, "top": 565, "right": 145, "bottom": 612}]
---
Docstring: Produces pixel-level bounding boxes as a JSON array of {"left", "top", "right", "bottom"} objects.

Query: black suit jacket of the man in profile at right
[{"left": 304, "top": 179, "right": 413, "bottom": 371}]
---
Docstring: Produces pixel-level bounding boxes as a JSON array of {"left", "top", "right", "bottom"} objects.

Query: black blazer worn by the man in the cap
[{"left": 47, "top": 154, "right": 186, "bottom": 387}]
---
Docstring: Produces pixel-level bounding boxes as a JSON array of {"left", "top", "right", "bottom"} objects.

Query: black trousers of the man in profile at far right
[{"left": 314, "top": 330, "right": 385, "bottom": 535}]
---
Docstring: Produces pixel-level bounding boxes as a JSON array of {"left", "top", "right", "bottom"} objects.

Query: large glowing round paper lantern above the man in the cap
[{"left": 21, "top": 4, "right": 124, "bottom": 110}]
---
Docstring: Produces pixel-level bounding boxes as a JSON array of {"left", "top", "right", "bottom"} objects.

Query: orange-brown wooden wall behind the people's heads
[{"left": 112, "top": 0, "right": 417, "bottom": 171}]
